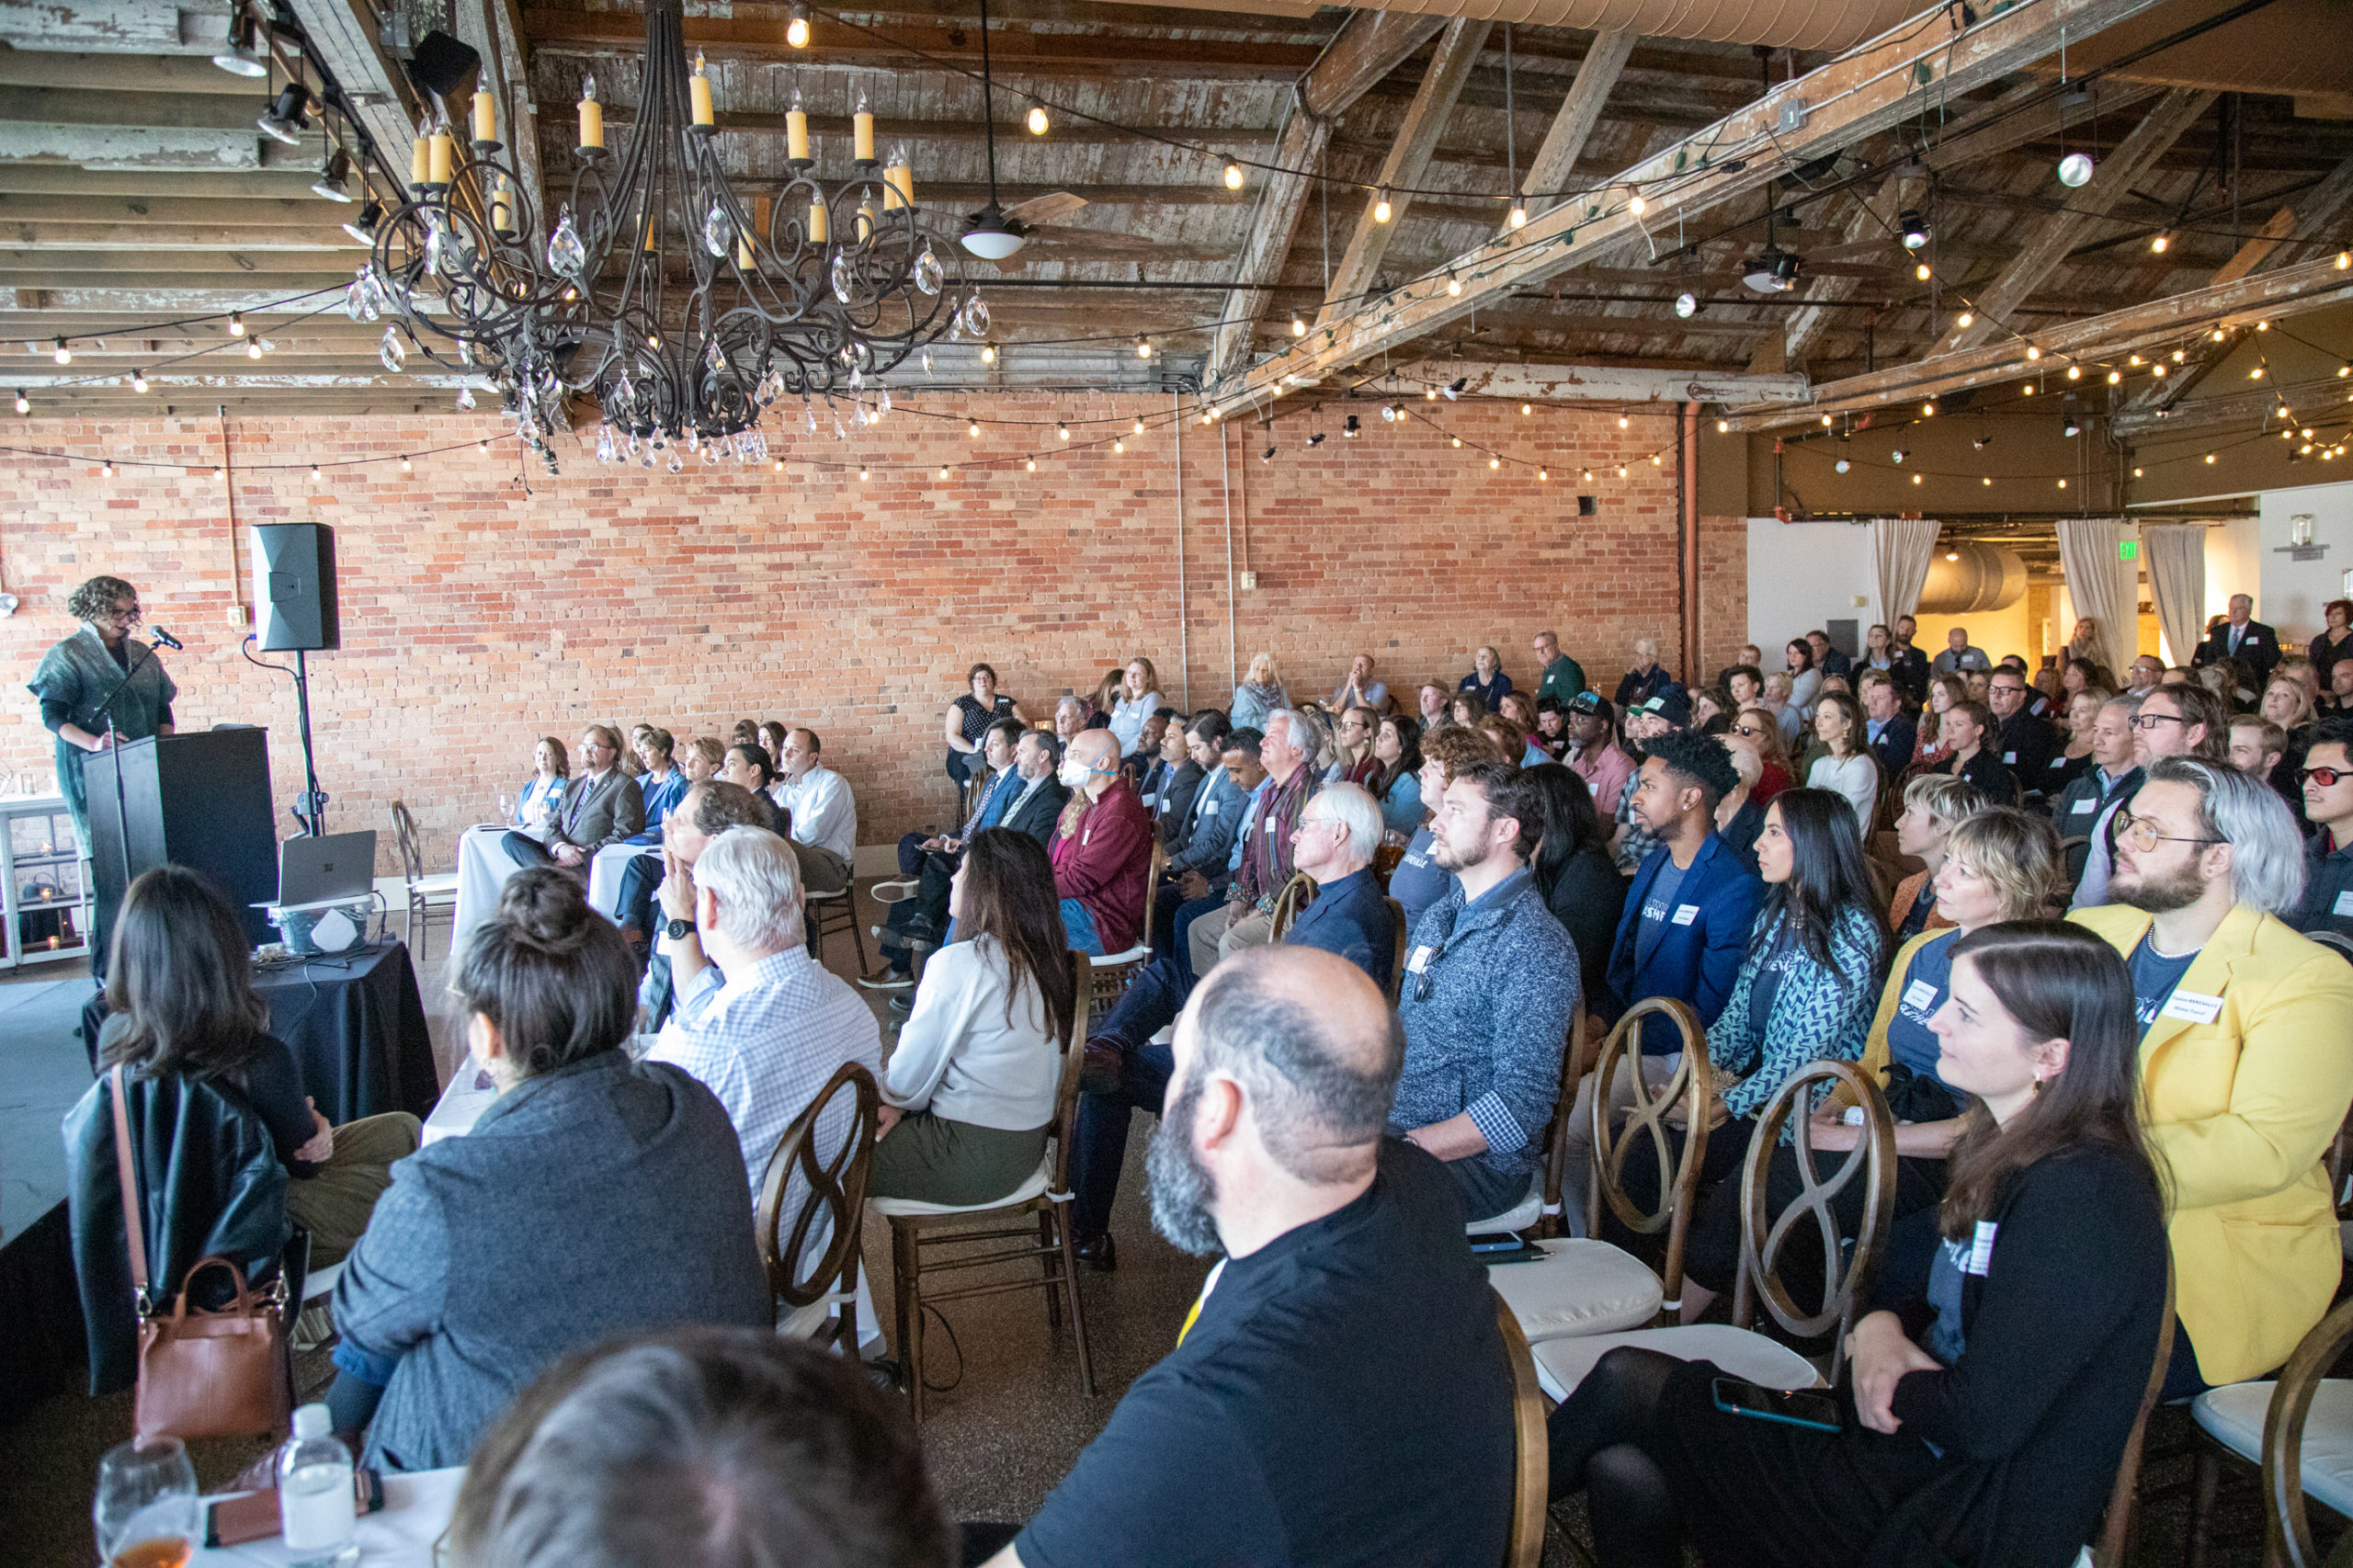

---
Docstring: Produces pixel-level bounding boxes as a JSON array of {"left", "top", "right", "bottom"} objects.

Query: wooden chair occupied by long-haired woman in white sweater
[{"left": 870, "top": 953, "right": 1094, "bottom": 1426}]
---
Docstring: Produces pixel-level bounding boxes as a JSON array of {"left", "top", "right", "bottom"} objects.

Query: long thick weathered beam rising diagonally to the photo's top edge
[{"left": 1211, "top": 0, "right": 2158, "bottom": 415}]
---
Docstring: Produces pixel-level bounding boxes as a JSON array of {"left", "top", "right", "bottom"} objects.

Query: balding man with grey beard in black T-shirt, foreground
[{"left": 967, "top": 947, "right": 1513, "bottom": 1568}]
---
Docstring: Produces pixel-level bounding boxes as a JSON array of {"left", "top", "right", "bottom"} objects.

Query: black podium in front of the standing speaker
[{"left": 83, "top": 728, "right": 278, "bottom": 950}]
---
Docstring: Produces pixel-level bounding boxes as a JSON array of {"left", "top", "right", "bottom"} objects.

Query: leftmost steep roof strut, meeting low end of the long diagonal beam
[{"left": 1210, "top": 12, "right": 1445, "bottom": 374}]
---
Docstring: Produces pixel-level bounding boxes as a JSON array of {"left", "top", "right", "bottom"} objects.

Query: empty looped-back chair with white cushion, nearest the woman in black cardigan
[{"left": 1537, "top": 1045, "right": 1896, "bottom": 1399}]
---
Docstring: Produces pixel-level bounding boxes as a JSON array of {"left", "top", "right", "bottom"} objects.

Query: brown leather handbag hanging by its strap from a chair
[{"left": 108, "top": 1066, "right": 294, "bottom": 1438}]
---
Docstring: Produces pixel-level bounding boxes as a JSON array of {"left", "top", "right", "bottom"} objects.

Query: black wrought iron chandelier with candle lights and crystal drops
[{"left": 346, "top": 0, "right": 988, "bottom": 473}]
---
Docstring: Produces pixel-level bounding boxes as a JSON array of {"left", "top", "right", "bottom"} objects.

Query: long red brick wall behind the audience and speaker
[{"left": 0, "top": 395, "right": 1746, "bottom": 869}]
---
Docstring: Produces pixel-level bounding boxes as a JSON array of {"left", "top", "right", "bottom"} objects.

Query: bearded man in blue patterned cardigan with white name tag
[{"left": 1391, "top": 763, "right": 1579, "bottom": 1221}]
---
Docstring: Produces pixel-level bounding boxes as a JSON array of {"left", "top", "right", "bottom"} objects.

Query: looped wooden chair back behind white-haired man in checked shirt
[{"left": 757, "top": 1062, "right": 882, "bottom": 1356}]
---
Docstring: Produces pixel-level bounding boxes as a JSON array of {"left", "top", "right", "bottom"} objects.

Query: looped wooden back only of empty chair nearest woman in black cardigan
[{"left": 1732, "top": 1062, "right": 1896, "bottom": 1382}]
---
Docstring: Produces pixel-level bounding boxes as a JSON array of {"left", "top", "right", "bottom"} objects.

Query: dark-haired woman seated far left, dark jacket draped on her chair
[{"left": 99, "top": 867, "right": 419, "bottom": 1269}]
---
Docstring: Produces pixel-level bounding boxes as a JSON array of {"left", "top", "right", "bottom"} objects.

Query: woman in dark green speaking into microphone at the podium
[{"left": 33, "top": 577, "right": 179, "bottom": 855}]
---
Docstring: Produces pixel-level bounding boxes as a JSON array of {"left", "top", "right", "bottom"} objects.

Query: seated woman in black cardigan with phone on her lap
[{"left": 1548, "top": 921, "right": 2167, "bottom": 1568}]
